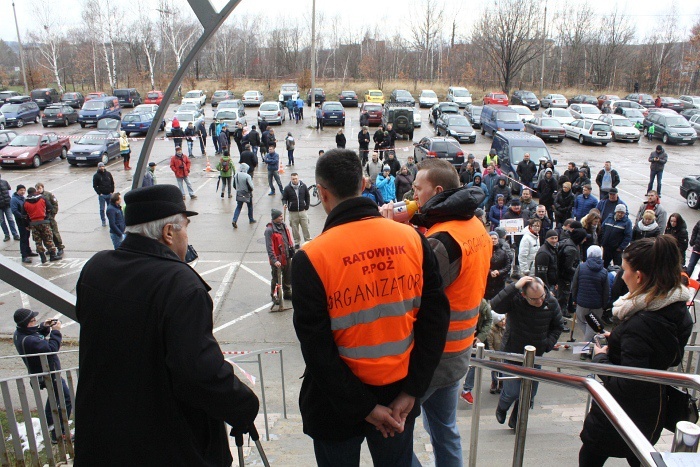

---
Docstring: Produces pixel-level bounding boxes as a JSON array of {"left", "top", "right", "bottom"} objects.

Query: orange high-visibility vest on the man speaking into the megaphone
[{"left": 426, "top": 217, "right": 493, "bottom": 353}]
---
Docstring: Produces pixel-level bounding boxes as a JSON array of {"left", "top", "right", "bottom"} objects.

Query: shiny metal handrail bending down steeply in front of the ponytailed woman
[{"left": 470, "top": 352, "right": 663, "bottom": 467}]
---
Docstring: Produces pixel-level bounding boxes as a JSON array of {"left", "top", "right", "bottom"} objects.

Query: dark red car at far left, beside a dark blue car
[{"left": 0, "top": 133, "right": 70, "bottom": 167}]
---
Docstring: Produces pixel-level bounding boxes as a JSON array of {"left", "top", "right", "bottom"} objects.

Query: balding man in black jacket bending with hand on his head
[{"left": 491, "top": 276, "right": 562, "bottom": 429}]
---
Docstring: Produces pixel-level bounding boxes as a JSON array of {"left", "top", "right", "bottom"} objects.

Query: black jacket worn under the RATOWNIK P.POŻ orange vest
[{"left": 292, "top": 197, "right": 450, "bottom": 440}]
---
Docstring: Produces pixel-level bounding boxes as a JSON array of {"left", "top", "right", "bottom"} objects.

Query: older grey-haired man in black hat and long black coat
[{"left": 75, "top": 184, "right": 258, "bottom": 466}]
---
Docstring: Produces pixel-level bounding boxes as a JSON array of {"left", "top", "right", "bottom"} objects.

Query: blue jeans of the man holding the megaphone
[{"left": 411, "top": 381, "right": 463, "bottom": 467}]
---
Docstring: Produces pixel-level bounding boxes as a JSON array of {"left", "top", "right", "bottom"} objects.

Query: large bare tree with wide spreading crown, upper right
[{"left": 473, "top": 0, "right": 542, "bottom": 93}]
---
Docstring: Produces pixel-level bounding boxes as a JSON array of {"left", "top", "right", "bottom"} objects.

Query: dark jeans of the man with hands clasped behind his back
[{"left": 314, "top": 417, "right": 416, "bottom": 467}]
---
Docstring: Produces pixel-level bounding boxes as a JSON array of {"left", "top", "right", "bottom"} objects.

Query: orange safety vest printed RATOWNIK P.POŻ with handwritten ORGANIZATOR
[{"left": 302, "top": 217, "right": 423, "bottom": 386}]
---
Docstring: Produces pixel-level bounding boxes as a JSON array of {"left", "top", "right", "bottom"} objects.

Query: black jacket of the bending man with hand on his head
[{"left": 491, "top": 284, "right": 563, "bottom": 357}]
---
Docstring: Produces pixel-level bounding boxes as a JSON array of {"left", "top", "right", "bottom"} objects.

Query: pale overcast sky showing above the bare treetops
[{"left": 0, "top": 0, "right": 700, "bottom": 41}]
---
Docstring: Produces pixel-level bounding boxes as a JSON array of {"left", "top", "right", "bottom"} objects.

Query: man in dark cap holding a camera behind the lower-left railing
[{"left": 12, "top": 308, "right": 73, "bottom": 444}]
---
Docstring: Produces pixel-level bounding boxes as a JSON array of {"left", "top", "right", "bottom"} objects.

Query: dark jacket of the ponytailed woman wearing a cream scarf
[{"left": 581, "top": 302, "right": 693, "bottom": 457}]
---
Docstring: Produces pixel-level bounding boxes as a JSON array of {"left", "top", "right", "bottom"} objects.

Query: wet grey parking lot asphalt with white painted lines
[{"left": 0, "top": 104, "right": 700, "bottom": 406}]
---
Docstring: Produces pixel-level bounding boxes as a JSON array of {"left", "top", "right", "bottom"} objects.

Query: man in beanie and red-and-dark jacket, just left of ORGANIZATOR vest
[{"left": 265, "top": 209, "right": 294, "bottom": 305}]
